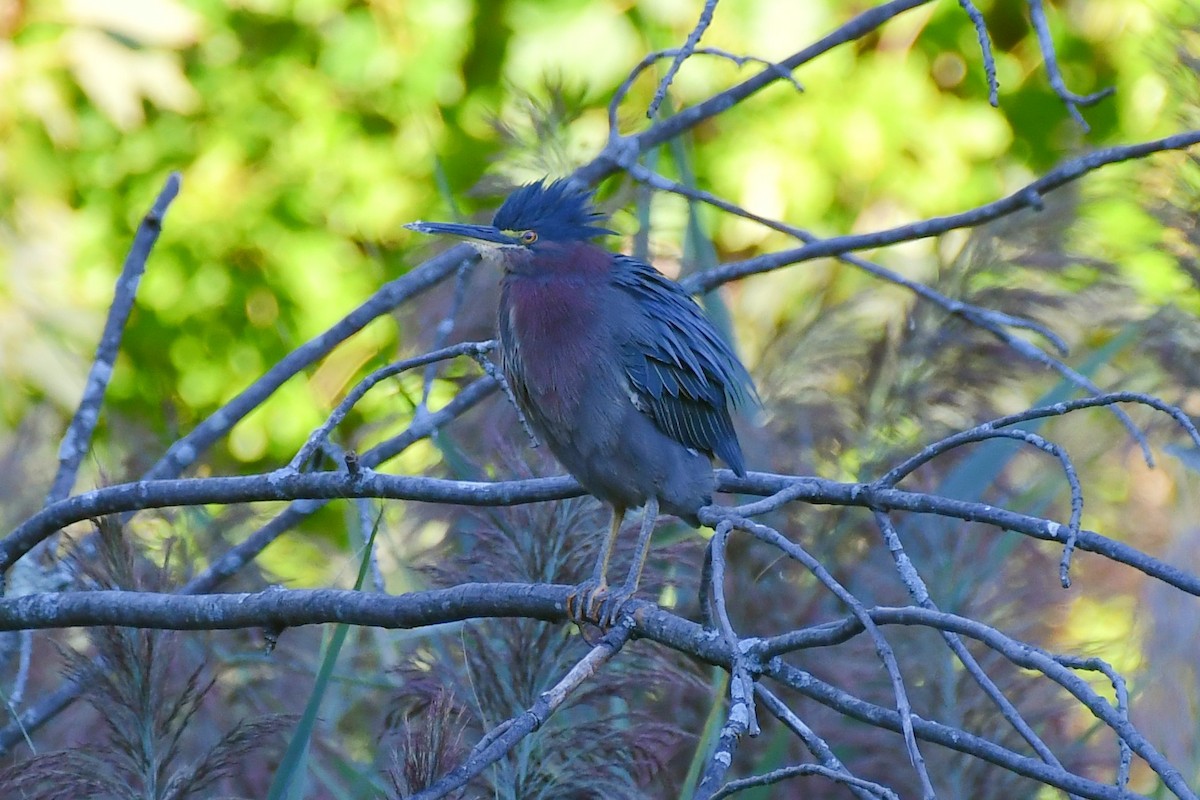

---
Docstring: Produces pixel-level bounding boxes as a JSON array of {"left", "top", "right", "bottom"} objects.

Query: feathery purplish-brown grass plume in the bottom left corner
[{"left": 0, "top": 517, "right": 288, "bottom": 800}]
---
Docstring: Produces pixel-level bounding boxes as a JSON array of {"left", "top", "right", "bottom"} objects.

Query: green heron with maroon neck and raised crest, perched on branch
[{"left": 407, "top": 180, "right": 757, "bottom": 626}]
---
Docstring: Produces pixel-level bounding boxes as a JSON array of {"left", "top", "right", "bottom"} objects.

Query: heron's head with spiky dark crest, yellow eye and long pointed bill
[{"left": 404, "top": 179, "right": 616, "bottom": 266}]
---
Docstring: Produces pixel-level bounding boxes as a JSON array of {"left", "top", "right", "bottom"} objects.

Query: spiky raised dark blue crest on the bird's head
[{"left": 492, "top": 178, "right": 617, "bottom": 240}]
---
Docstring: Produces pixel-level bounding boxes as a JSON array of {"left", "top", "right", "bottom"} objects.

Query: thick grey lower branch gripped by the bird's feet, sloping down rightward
[{"left": 0, "top": 583, "right": 1161, "bottom": 800}]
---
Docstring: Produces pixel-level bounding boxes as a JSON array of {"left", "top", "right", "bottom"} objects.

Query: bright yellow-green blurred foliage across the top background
[{"left": 0, "top": 0, "right": 1186, "bottom": 467}]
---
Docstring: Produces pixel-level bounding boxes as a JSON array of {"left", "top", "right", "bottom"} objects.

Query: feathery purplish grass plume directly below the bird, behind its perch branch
[{"left": 389, "top": 482, "right": 702, "bottom": 800}]
